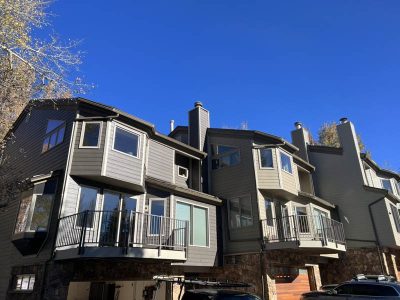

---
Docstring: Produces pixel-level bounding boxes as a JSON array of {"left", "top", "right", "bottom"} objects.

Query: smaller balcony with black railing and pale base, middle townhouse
[{"left": 261, "top": 215, "right": 346, "bottom": 254}]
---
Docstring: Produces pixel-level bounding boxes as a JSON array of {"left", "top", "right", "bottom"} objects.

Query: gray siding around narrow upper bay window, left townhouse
[{"left": 70, "top": 122, "right": 107, "bottom": 176}]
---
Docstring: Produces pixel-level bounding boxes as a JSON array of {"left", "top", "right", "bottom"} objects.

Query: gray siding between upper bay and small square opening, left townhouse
[{"left": 147, "top": 140, "right": 175, "bottom": 182}]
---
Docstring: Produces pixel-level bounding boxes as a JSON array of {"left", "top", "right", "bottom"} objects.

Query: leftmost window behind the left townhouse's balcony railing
[{"left": 76, "top": 186, "right": 97, "bottom": 228}]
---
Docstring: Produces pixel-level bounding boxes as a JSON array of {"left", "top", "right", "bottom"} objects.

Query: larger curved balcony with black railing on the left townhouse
[{"left": 55, "top": 210, "right": 189, "bottom": 262}]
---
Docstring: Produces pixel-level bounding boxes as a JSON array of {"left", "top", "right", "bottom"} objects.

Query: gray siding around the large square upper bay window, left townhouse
[{"left": 105, "top": 123, "right": 146, "bottom": 185}]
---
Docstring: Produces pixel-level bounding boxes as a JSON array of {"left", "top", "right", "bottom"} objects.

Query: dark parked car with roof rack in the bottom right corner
[{"left": 300, "top": 280, "right": 400, "bottom": 300}]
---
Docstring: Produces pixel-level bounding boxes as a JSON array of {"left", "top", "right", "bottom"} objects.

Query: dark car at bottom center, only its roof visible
[{"left": 182, "top": 289, "right": 261, "bottom": 300}]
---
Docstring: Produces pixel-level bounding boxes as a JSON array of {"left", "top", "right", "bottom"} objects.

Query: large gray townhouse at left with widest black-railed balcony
[{"left": 0, "top": 98, "right": 222, "bottom": 300}]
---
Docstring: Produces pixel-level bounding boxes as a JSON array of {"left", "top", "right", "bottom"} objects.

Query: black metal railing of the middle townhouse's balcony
[{"left": 261, "top": 215, "right": 346, "bottom": 245}]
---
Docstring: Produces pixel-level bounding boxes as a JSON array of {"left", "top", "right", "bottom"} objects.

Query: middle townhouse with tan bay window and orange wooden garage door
[{"left": 170, "top": 103, "right": 346, "bottom": 300}]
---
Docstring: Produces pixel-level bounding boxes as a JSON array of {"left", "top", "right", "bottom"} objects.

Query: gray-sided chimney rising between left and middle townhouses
[{"left": 189, "top": 101, "right": 210, "bottom": 151}]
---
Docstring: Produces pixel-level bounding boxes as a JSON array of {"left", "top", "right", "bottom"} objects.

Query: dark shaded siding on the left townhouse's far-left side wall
[{"left": 0, "top": 105, "right": 76, "bottom": 299}]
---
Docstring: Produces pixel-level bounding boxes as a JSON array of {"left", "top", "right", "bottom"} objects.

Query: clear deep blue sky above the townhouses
[{"left": 51, "top": 0, "right": 400, "bottom": 171}]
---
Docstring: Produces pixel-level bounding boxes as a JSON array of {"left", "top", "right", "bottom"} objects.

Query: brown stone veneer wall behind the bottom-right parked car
[{"left": 320, "top": 247, "right": 400, "bottom": 284}]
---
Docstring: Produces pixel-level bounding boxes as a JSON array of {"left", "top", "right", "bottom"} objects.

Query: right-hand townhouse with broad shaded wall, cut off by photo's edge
[{"left": 292, "top": 118, "right": 400, "bottom": 282}]
